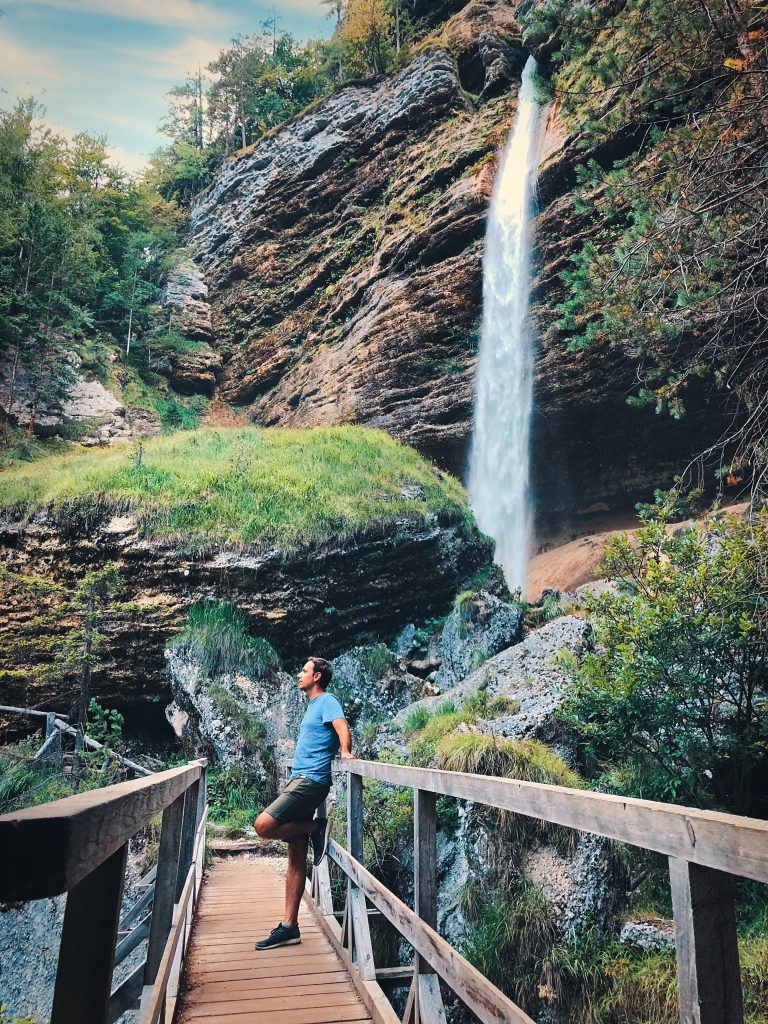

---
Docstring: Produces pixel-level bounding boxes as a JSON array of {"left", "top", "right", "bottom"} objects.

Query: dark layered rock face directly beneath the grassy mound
[{"left": 0, "top": 512, "right": 489, "bottom": 705}]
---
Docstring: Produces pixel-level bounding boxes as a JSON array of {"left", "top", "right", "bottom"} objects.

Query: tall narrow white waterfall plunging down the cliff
[{"left": 469, "top": 57, "right": 547, "bottom": 591}]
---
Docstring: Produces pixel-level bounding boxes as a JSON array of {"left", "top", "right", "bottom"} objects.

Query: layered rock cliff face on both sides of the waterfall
[{"left": 186, "top": 0, "right": 720, "bottom": 535}]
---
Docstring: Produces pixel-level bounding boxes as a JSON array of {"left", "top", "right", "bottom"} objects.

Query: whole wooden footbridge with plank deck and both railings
[{"left": 0, "top": 761, "right": 768, "bottom": 1024}]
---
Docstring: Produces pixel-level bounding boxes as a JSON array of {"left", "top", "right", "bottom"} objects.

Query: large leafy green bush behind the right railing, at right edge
[{"left": 563, "top": 507, "right": 768, "bottom": 816}]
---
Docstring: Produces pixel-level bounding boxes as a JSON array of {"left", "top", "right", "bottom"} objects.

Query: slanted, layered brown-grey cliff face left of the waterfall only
[{"left": 193, "top": 4, "right": 523, "bottom": 471}]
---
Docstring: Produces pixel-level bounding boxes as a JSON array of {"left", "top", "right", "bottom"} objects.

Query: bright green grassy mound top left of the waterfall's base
[{"left": 0, "top": 426, "right": 472, "bottom": 549}]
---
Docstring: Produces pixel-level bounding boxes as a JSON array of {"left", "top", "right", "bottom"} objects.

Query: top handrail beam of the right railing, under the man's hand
[{"left": 335, "top": 760, "right": 768, "bottom": 882}]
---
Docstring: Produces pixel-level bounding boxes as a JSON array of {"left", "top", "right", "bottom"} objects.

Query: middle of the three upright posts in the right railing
[{"left": 414, "top": 790, "right": 445, "bottom": 1024}]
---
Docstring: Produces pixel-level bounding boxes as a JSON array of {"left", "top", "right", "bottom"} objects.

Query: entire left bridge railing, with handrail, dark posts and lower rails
[{"left": 0, "top": 761, "right": 207, "bottom": 1024}]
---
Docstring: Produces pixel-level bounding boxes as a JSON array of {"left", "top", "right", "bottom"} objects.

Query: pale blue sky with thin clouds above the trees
[{"left": 0, "top": 0, "right": 332, "bottom": 171}]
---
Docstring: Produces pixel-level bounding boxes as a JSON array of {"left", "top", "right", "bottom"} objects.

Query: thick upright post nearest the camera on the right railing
[{"left": 670, "top": 857, "right": 743, "bottom": 1024}]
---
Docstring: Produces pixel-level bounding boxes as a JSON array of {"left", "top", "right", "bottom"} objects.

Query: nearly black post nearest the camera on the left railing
[{"left": 50, "top": 843, "right": 128, "bottom": 1024}]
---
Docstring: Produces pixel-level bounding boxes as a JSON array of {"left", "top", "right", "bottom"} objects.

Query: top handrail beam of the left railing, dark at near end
[{"left": 0, "top": 762, "right": 203, "bottom": 902}]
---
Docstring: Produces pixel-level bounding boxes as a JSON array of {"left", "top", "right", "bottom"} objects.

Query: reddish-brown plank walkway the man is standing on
[{"left": 177, "top": 857, "right": 371, "bottom": 1024}]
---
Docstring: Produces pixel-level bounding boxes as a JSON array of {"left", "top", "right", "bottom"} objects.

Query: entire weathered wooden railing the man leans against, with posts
[{"left": 311, "top": 761, "right": 768, "bottom": 1024}]
